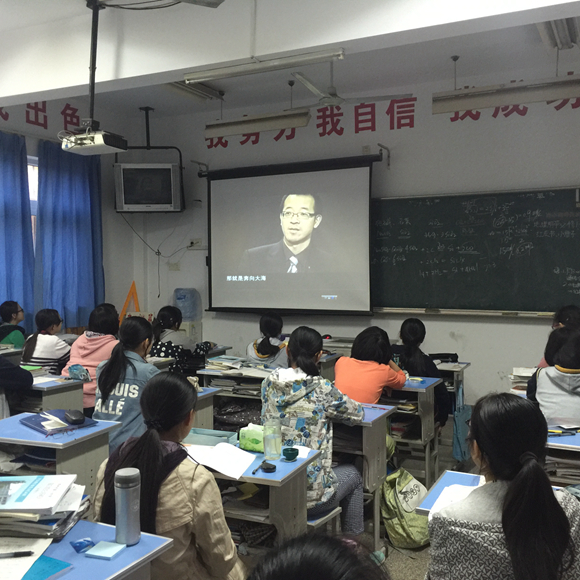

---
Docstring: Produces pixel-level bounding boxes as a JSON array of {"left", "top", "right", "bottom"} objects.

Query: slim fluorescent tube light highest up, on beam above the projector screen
[{"left": 183, "top": 48, "right": 344, "bottom": 84}]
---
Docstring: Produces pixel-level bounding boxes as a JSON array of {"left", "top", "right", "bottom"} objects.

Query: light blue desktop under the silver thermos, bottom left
[{"left": 44, "top": 520, "right": 173, "bottom": 580}]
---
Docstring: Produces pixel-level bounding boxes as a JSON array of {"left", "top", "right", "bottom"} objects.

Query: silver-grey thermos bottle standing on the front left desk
[{"left": 115, "top": 467, "right": 141, "bottom": 546}]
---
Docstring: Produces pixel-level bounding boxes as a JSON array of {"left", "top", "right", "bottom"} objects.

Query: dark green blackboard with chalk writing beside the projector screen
[{"left": 370, "top": 189, "right": 580, "bottom": 312}]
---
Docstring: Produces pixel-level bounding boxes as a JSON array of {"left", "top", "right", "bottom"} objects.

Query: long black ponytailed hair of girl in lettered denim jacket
[{"left": 97, "top": 316, "right": 153, "bottom": 404}]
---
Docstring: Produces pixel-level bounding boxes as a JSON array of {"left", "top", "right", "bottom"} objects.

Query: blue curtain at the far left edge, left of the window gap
[{"left": 0, "top": 132, "right": 34, "bottom": 332}]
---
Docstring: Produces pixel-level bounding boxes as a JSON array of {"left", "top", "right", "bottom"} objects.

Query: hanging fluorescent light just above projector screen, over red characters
[{"left": 205, "top": 109, "right": 310, "bottom": 139}]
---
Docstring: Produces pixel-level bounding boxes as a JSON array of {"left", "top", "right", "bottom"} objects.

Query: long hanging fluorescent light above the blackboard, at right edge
[{"left": 432, "top": 75, "right": 580, "bottom": 115}]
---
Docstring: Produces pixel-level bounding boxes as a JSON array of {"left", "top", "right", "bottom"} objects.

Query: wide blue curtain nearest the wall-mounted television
[{"left": 34, "top": 141, "right": 105, "bottom": 327}]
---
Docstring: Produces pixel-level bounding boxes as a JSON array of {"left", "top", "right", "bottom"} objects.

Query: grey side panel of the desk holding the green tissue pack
[{"left": 270, "top": 469, "right": 307, "bottom": 543}]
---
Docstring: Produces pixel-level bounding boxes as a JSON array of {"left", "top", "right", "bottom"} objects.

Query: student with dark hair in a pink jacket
[{"left": 62, "top": 305, "right": 119, "bottom": 417}]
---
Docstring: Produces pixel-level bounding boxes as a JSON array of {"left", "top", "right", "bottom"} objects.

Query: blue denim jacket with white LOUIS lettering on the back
[{"left": 93, "top": 350, "right": 160, "bottom": 453}]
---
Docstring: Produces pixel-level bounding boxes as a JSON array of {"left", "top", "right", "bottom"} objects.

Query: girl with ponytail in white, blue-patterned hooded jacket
[{"left": 261, "top": 326, "right": 364, "bottom": 535}]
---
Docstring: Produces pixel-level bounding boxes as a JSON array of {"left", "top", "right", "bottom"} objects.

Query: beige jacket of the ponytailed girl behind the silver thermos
[{"left": 95, "top": 450, "right": 247, "bottom": 580}]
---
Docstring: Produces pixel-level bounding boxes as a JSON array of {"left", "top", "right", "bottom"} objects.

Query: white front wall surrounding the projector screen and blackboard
[{"left": 94, "top": 61, "right": 580, "bottom": 402}]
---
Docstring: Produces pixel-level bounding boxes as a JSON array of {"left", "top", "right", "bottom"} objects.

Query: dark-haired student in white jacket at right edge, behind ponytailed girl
[{"left": 535, "top": 328, "right": 580, "bottom": 421}]
